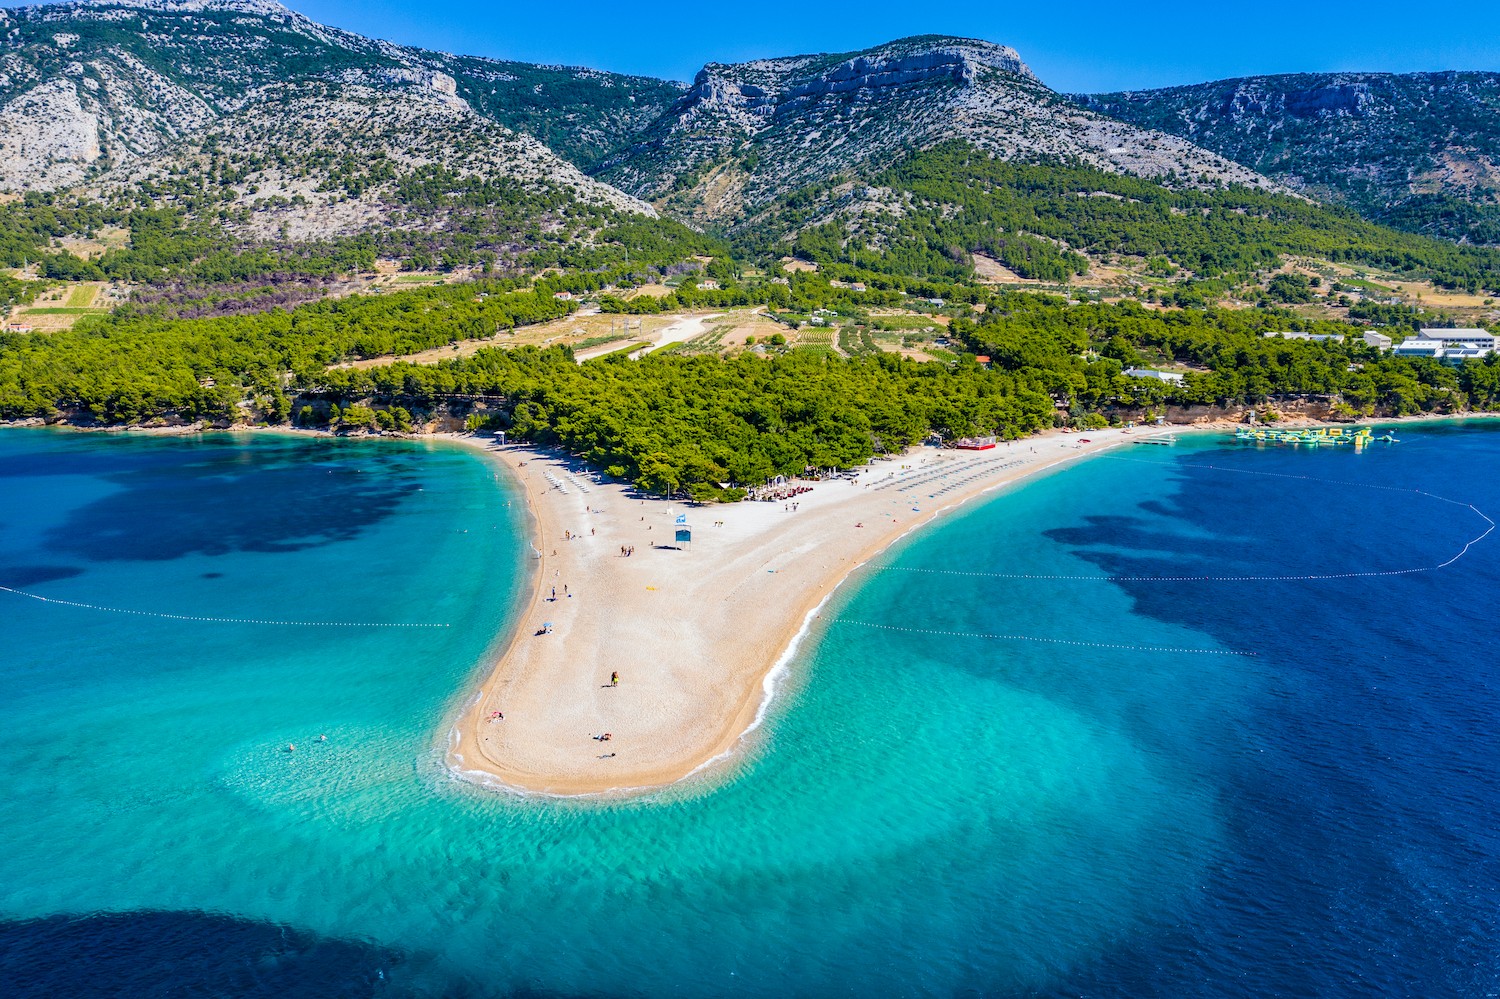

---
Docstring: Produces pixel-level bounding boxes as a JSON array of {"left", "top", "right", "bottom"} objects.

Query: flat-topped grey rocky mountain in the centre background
[{"left": 597, "top": 36, "right": 1269, "bottom": 224}]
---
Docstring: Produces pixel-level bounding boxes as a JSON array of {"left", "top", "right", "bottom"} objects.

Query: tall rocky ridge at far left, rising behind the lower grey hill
[{"left": 0, "top": 0, "right": 681, "bottom": 191}]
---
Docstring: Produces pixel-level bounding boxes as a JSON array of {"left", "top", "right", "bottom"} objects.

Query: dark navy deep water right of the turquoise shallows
[{"left": 1044, "top": 432, "right": 1500, "bottom": 999}]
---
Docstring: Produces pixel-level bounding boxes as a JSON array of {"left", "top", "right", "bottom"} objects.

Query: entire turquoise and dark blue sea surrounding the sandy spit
[{"left": 0, "top": 423, "right": 1500, "bottom": 999}]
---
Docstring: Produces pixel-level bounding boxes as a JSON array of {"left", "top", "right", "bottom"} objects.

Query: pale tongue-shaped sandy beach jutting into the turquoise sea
[{"left": 449, "top": 428, "right": 1161, "bottom": 795}]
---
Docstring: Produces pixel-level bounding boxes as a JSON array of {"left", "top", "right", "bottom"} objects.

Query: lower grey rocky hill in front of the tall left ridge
[{"left": 80, "top": 84, "right": 656, "bottom": 243}]
